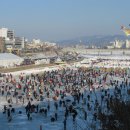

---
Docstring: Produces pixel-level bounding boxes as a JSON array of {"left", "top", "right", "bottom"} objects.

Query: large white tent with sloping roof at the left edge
[{"left": 0, "top": 53, "right": 24, "bottom": 68}]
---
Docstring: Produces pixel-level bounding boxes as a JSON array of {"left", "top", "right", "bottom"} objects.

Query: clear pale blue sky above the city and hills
[{"left": 0, "top": 0, "right": 130, "bottom": 41}]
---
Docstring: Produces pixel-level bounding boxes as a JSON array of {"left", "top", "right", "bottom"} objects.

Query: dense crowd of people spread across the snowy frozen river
[{"left": 0, "top": 68, "right": 130, "bottom": 130}]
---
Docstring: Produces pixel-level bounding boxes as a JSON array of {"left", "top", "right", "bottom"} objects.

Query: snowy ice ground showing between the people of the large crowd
[{"left": 0, "top": 57, "right": 130, "bottom": 130}]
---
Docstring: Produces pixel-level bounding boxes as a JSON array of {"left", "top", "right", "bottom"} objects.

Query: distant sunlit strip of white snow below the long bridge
[{"left": 75, "top": 55, "right": 130, "bottom": 68}]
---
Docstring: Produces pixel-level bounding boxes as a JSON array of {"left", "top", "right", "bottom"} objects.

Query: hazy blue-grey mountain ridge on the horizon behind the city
[{"left": 57, "top": 35, "right": 130, "bottom": 46}]
